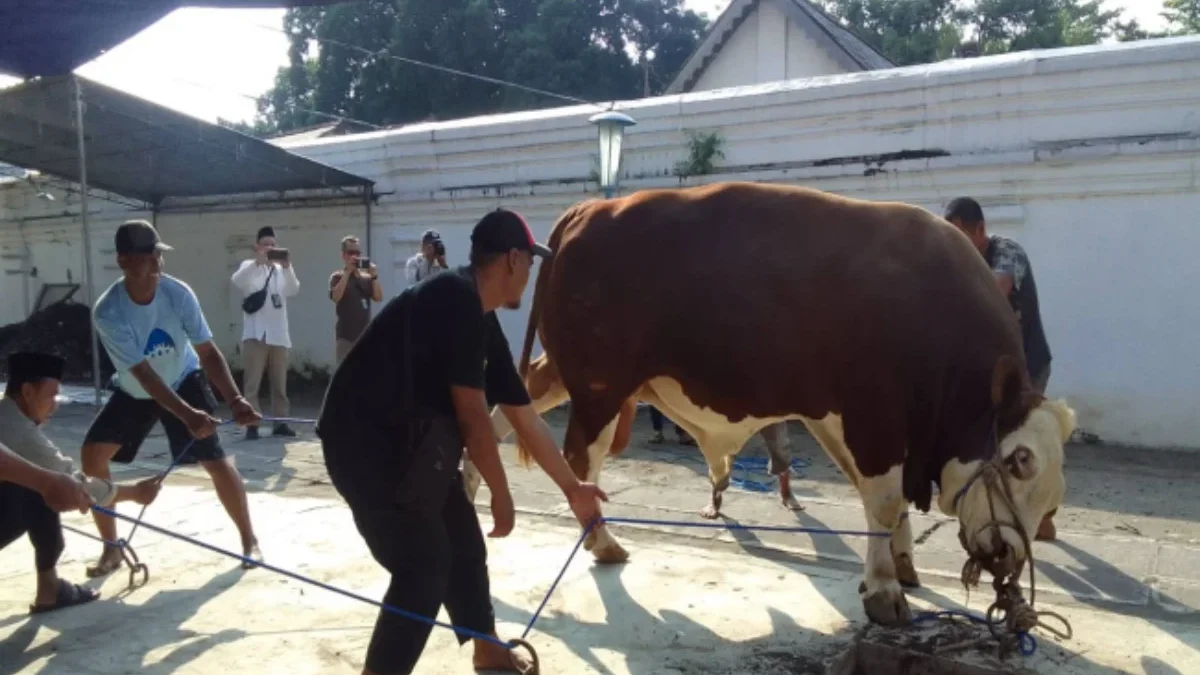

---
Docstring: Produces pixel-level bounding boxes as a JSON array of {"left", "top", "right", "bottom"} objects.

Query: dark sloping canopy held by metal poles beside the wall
[{"left": 0, "top": 74, "right": 372, "bottom": 205}]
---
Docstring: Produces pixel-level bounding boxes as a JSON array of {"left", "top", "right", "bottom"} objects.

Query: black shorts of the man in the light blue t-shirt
[{"left": 83, "top": 370, "right": 226, "bottom": 464}]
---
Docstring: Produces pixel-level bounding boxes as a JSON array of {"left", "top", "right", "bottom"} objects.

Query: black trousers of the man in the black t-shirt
[{"left": 322, "top": 419, "right": 496, "bottom": 675}]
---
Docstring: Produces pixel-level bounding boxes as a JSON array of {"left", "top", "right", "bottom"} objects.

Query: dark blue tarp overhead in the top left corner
[{"left": 0, "top": 0, "right": 344, "bottom": 79}]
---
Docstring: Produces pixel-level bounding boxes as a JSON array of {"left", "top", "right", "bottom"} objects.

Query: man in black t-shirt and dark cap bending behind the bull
[{"left": 316, "top": 209, "right": 607, "bottom": 675}]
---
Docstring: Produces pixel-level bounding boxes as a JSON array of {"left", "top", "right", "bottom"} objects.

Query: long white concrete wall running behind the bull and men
[{"left": 0, "top": 38, "right": 1200, "bottom": 447}]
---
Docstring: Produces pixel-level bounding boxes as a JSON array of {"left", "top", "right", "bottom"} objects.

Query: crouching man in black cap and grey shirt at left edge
[{"left": 0, "top": 352, "right": 162, "bottom": 614}]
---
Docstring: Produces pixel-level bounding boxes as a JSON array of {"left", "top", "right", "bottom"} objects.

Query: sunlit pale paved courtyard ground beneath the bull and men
[{"left": 0, "top": 386, "right": 1200, "bottom": 675}]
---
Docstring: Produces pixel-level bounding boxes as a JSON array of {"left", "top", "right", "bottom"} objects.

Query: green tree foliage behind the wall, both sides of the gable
[{"left": 241, "top": 0, "right": 1200, "bottom": 136}]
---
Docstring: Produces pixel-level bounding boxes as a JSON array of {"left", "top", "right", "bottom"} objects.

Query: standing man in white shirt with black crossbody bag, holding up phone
[{"left": 230, "top": 227, "right": 300, "bottom": 441}]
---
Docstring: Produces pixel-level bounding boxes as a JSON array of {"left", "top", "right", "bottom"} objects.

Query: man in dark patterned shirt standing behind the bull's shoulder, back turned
[{"left": 943, "top": 197, "right": 1056, "bottom": 540}]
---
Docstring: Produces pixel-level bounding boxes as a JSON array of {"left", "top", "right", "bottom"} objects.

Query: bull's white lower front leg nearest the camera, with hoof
[{"left": 859, "top": 466, "right": 912, "bottom": 626}]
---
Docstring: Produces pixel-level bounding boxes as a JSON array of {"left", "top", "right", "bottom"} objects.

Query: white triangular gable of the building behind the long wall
[{"left": 692, "top": 2, "right": 846, "bottom": 91}]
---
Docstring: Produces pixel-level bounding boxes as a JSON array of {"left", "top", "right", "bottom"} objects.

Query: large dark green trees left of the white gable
[{"left": 253, "top": 0, "right": 707, "bottom": 131}]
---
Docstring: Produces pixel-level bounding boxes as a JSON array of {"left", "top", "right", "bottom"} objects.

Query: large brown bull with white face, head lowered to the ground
[{"left": 517, "top": 183, "right": 1075, "bottom": 623}]
